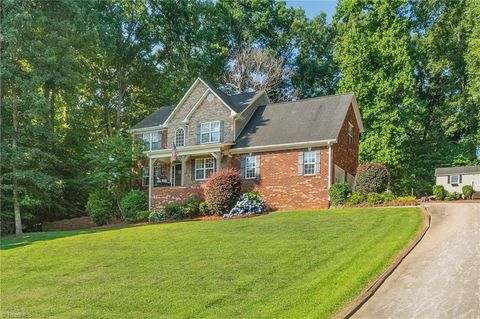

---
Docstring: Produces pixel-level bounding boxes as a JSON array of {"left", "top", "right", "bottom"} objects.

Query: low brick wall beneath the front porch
[{"left": 152, "top": 184, "right": 203, "bottom": 210}]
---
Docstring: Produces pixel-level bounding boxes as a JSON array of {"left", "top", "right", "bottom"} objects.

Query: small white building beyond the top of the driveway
[{"left": 435, "top": 166, "right": 480, "bottom": 193}]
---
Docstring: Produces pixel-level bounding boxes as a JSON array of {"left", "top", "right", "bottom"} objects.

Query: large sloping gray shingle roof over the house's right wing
[{"left": 234, "top": 93, "right": 354, "bottom": 148}]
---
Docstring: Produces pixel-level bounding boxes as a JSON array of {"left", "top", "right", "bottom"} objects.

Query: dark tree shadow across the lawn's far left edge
[{"left": 0, "top": 225, "right": 131, "bottom": 250}]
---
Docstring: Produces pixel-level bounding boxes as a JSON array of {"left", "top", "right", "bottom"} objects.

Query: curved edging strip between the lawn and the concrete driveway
[{"left": 333, "top": 205, "right": 431, "bottom": 319}]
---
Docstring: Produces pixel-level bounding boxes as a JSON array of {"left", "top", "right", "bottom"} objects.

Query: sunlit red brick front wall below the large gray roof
[{"left": 232, "top": 147, "right": 328, "bottom": 210}]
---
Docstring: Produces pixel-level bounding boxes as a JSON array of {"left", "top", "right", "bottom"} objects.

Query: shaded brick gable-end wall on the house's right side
[{"left": 332, "top": 105, "right": 360, "bottom": 182}]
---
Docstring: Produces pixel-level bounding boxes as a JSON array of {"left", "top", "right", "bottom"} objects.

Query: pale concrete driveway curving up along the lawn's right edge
[{"left": 353, "top": 203, "right": 480, "bottom": 319}]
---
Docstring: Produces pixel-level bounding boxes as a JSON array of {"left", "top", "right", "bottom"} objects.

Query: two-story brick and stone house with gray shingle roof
[{"left": 131, "top": 78, "right": 363, "bottom": 210}]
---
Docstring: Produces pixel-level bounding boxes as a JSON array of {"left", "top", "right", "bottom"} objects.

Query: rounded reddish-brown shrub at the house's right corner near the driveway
[{"left": 355, "top": 163, "right": 390, "bottom": 196}]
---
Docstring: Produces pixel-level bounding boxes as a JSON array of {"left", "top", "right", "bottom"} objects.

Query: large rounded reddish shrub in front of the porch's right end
[{"left": 205, "top": 169, "right": 242, "bottom": 215}]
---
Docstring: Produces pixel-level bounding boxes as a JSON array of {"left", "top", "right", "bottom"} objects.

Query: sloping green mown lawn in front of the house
[{"left": 1, "top": 208, "right": 422, "bottom": 318}]
